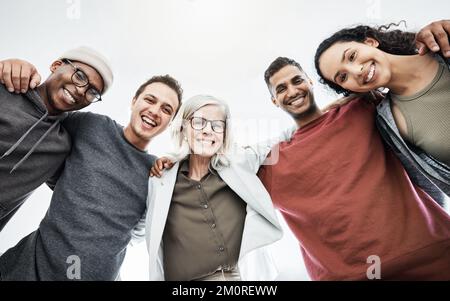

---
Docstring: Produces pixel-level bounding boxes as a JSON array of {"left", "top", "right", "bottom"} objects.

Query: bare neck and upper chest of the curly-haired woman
[{"left": 387, "top": 55, "right": 439, "bottom": 95}]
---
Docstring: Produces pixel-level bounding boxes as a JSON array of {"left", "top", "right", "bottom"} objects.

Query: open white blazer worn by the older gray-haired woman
[{"left": 145, "top": 129, "right": 293, "bottom": 281}]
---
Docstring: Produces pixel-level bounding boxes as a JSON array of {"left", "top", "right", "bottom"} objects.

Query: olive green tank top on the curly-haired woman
[{"left": 391, "top": 57, "right": 450, "bottom": 166}]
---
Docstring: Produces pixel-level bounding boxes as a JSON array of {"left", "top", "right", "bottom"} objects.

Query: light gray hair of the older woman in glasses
[{"left": 171, "top": 95, "right": 232, "bottom": 170}]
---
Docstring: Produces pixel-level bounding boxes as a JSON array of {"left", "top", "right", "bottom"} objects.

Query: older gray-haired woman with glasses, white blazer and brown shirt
[{"left": 146, "top": 95, "right": 290, "bottom": 280}]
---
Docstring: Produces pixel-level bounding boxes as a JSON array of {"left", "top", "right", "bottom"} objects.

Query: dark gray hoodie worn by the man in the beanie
[{"left": 0, "top": 85, "right": 71, "bottom": 231}]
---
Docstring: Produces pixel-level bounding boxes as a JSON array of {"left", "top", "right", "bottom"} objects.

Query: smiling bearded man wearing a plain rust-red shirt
[{"left": 259, "top": 57, "right": 450, "bottom": 280}]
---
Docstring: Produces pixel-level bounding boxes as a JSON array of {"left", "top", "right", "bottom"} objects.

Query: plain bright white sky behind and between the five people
[{"left": 0, "top": 0, "right": 450, "bottom": 280}]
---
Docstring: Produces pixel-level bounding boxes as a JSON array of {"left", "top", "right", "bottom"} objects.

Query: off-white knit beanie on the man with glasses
[{"left": 58, "top": 46, "right": 114, "bottom": 94}]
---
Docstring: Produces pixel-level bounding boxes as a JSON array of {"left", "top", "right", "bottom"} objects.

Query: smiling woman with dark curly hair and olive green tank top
[{"left": 315, "top": 24, "right": 450, "bottom": 206}]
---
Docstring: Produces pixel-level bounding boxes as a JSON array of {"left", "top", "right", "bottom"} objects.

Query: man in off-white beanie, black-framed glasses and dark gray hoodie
[{"left": 0, "top": 47, "right": 113, "bottom": 231}]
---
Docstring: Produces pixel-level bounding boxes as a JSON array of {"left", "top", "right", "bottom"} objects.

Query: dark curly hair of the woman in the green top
[{"left": 314, "top": 21, "right": 417, "bottom": 96}]
